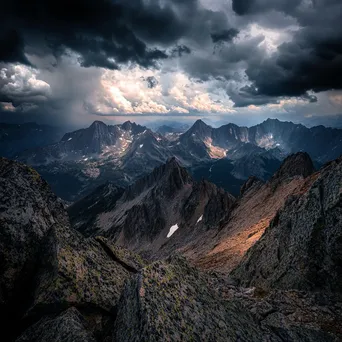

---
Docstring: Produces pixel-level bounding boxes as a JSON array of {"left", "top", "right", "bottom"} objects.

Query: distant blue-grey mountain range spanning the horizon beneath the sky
[{"left": 4, "top": 119, "right": 342, "bottom": 201}]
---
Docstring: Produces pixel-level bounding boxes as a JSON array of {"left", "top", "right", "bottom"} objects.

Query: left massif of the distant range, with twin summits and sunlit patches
[{"left": 17, "top": 121, "right": 173, "bottom": 201}]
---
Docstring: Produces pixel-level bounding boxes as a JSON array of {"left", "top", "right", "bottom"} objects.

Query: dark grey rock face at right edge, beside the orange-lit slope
[{"left": 233, "top": 159, "right": 342, "bottom": 292}]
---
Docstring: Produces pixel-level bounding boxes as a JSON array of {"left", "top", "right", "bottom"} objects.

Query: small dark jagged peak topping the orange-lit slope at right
[{"left": 271, "top": 152, "right": 315, "bottom": 181}]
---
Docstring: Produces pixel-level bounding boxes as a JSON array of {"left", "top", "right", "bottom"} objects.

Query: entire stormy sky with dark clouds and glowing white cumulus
[{"left": 0, "top": 0, "right": 342, "bottom": 125}]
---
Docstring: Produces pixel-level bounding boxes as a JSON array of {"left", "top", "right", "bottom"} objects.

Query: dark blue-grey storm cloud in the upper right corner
[{"left": 233, "top": 0, "right": 342, "bottom": 106}]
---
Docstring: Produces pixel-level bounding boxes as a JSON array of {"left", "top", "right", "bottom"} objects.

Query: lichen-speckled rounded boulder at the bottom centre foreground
[{"left": 114, "top": 257, "right": 262, "bottom": 342}]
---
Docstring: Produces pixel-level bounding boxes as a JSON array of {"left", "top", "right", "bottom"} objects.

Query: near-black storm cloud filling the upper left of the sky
[{"left": 0, "top": 0, "right": 192, "bottom": 69}]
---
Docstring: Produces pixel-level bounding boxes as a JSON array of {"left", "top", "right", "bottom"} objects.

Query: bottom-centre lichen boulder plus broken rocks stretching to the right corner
[{"left": 113, "top": 256, "right": 341, "bottom": 342}]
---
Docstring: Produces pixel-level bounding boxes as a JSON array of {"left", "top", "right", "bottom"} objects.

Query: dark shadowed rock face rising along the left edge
[{"left": 0, "top": 158, "right": 68, "bottom": 340}]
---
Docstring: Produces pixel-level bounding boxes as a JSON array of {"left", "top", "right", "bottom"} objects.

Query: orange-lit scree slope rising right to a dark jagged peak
[{"left": 187, "top": 152, "right": 313, "bottom": 272}]
